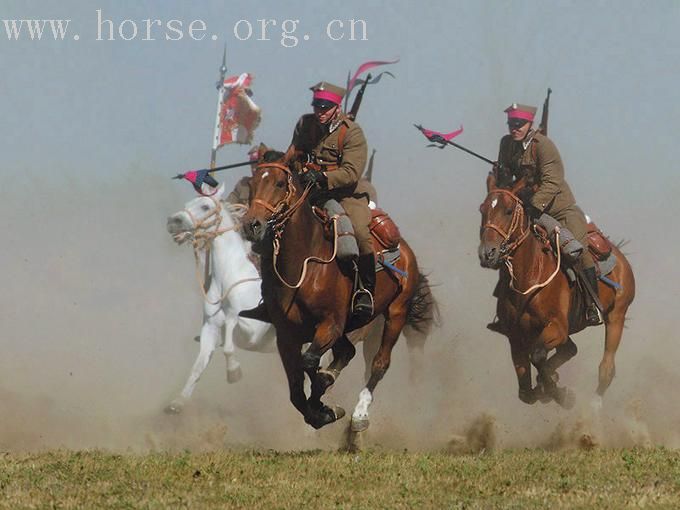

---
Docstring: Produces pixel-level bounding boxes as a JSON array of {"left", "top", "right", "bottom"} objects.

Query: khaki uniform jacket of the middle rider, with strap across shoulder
[{"left": 291, "top": 113, "right": 368, "bottom": 198}]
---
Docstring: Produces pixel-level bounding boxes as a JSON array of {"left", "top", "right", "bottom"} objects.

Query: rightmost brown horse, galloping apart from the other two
[{"left": 479, "top": 179, "right": 635, "bottom": 408}]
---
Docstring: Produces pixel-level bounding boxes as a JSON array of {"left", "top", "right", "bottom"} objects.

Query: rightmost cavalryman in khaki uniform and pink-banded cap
[{"left": 494, "top": 103, "right": 602, "bottom": 325}]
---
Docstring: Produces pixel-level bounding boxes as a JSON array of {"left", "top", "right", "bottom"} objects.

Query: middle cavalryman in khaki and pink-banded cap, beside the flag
[{"left": 240, "top": 81, "right": 375, "bottom": 320}]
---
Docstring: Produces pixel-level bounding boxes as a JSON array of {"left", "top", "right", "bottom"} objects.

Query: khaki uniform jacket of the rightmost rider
[{"left": 498, "top": 131, "right": 576, "bottom": 216}]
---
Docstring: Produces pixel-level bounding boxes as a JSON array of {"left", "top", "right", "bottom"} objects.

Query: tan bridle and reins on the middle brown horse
[{"left": 252, "top": 163, "right": 338, "bottom": 289}]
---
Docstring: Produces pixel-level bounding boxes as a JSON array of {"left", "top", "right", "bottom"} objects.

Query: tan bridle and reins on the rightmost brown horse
[{"left": 482, "top": 189, "right": 562, "bottom": 296}]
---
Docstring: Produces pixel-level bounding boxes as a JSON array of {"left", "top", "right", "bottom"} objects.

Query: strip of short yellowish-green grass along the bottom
[{"left": 0, "top": 448, "right": 680, "bottom": 509}]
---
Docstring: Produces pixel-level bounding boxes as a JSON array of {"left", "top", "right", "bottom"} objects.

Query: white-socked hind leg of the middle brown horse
[{"left": 351, "top": 303, "right": 407, "bottom": 432}]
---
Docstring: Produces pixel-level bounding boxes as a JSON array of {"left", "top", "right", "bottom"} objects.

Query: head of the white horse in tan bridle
[{"left": 168, "top": 184, "right": 234, "bottom": 244}]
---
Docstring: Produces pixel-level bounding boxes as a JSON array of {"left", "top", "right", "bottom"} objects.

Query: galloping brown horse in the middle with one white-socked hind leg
[{"left": 242, "top": 162, "right": 436, "bottom": 431}]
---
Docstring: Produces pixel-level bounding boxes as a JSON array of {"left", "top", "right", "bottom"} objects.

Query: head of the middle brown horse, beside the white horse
[{"left": 242, "top": 151, "right": 304, "bottom": 252}]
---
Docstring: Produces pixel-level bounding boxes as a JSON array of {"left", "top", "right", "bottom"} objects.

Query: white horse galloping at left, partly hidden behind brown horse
[{"left": 165, "top": 185, "right": 276, "bottom": 413}]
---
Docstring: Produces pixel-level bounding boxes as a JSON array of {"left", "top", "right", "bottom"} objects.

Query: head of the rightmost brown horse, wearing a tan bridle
[{"left": 478, "top": 180, "right": 528, "bottom": 269}]
